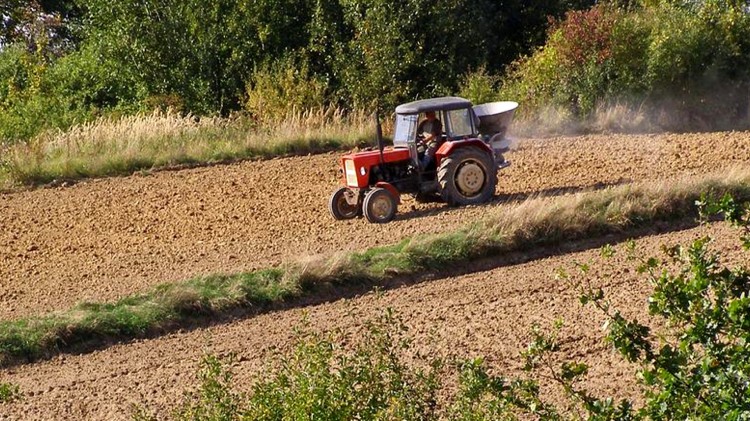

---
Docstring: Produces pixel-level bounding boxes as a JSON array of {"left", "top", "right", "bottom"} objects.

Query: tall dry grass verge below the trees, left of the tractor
[{"left": 0, "top": 108, "right": 375, "bottom": 187}]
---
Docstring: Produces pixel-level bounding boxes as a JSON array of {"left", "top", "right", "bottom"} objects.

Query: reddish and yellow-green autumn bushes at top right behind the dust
[{"left": 502, "top": 0, "right": 750, "bottom": 131}]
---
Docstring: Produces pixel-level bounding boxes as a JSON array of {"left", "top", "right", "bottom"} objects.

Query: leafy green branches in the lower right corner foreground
[{"left": 582, "top": 195, "right": 750, "bottom": 419}]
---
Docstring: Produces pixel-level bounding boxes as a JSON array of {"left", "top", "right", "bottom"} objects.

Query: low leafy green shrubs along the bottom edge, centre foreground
[{"left": 163, "top": 309, "right": 634, "bottom": 421}]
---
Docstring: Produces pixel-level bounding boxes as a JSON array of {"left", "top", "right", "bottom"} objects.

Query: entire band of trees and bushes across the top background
[{"left": 0, "top": 0, "right": 750, "bottom": 144}]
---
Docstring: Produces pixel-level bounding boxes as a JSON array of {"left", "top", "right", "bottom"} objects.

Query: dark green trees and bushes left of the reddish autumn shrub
[{"left": 0, "top": 0, "right": 594, "bottom": 142}]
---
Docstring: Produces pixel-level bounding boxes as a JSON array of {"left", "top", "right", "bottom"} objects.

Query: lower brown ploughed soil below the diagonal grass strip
[{"left": 0, "top": 221, "right": 741, "bottom": 420}]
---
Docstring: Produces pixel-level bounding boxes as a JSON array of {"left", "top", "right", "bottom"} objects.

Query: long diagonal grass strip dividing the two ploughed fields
[{"left": 0, "top": 170, "right": 750, "bottom": 364}]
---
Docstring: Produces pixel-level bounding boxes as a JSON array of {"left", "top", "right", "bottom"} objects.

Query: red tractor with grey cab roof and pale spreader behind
[{"left": 329, "top": 97, "right": 518, "bottom": 223}]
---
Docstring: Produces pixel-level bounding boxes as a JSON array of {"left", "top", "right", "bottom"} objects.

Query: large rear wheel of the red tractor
[{"left": 437, "top": 147, "right": 497, "bottom": 206}]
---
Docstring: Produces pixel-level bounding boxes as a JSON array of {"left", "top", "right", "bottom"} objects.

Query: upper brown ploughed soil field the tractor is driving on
[{"left": 0, "top": 132, "right": 750, "bottom": 319}]
